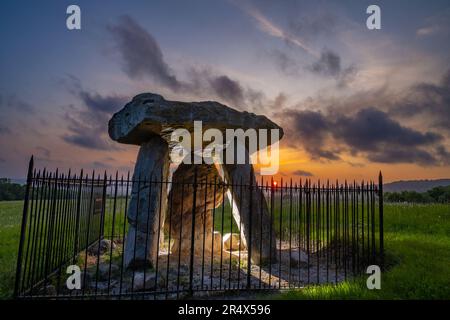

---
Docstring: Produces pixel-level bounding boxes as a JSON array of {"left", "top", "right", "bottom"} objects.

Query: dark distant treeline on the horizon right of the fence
[{"left": 384, "top": 186, "right": 450, "bottom": 203}]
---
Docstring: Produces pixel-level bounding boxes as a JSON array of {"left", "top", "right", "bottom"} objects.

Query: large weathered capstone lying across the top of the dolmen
[{"left": 109, "top": 93, "right": 283, "bottom": 145}]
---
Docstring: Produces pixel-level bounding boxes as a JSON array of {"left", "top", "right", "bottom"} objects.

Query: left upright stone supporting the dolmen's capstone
[{"left": 125, "top": 136, "right": 169, "bottom": 268}]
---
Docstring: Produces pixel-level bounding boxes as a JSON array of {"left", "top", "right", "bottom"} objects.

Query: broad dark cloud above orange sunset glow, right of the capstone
[{"left": 279, "top": 108, "right": 446, "bottom": 165}]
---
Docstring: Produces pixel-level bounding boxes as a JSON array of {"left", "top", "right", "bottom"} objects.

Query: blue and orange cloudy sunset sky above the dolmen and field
[{"left": 0, "top": 0, "right": 450, "bottom": 180}]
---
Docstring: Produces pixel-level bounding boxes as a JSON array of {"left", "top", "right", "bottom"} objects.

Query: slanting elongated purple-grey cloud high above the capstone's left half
[{"left": 108, "top": 16, "right": 182, "bottom": 91}]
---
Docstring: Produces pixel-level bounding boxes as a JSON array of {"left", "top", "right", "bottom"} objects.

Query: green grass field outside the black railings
[{"left": 0, "top": 201, "right": 450, "bottom": 299}]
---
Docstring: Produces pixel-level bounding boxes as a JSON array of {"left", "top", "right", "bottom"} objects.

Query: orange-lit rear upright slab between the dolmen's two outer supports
[{"left": 164, "top": 163, "right": 224, "bottom": 259}]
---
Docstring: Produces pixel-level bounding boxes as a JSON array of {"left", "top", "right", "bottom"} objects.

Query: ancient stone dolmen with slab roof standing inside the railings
[{"left": 109, "top": 93, "right": 283, "bottom": 268}]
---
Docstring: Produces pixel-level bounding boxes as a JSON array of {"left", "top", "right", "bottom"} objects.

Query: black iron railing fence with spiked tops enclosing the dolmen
[{"left": 15, "top": 159, "right": 383, "bottom": 299}]
